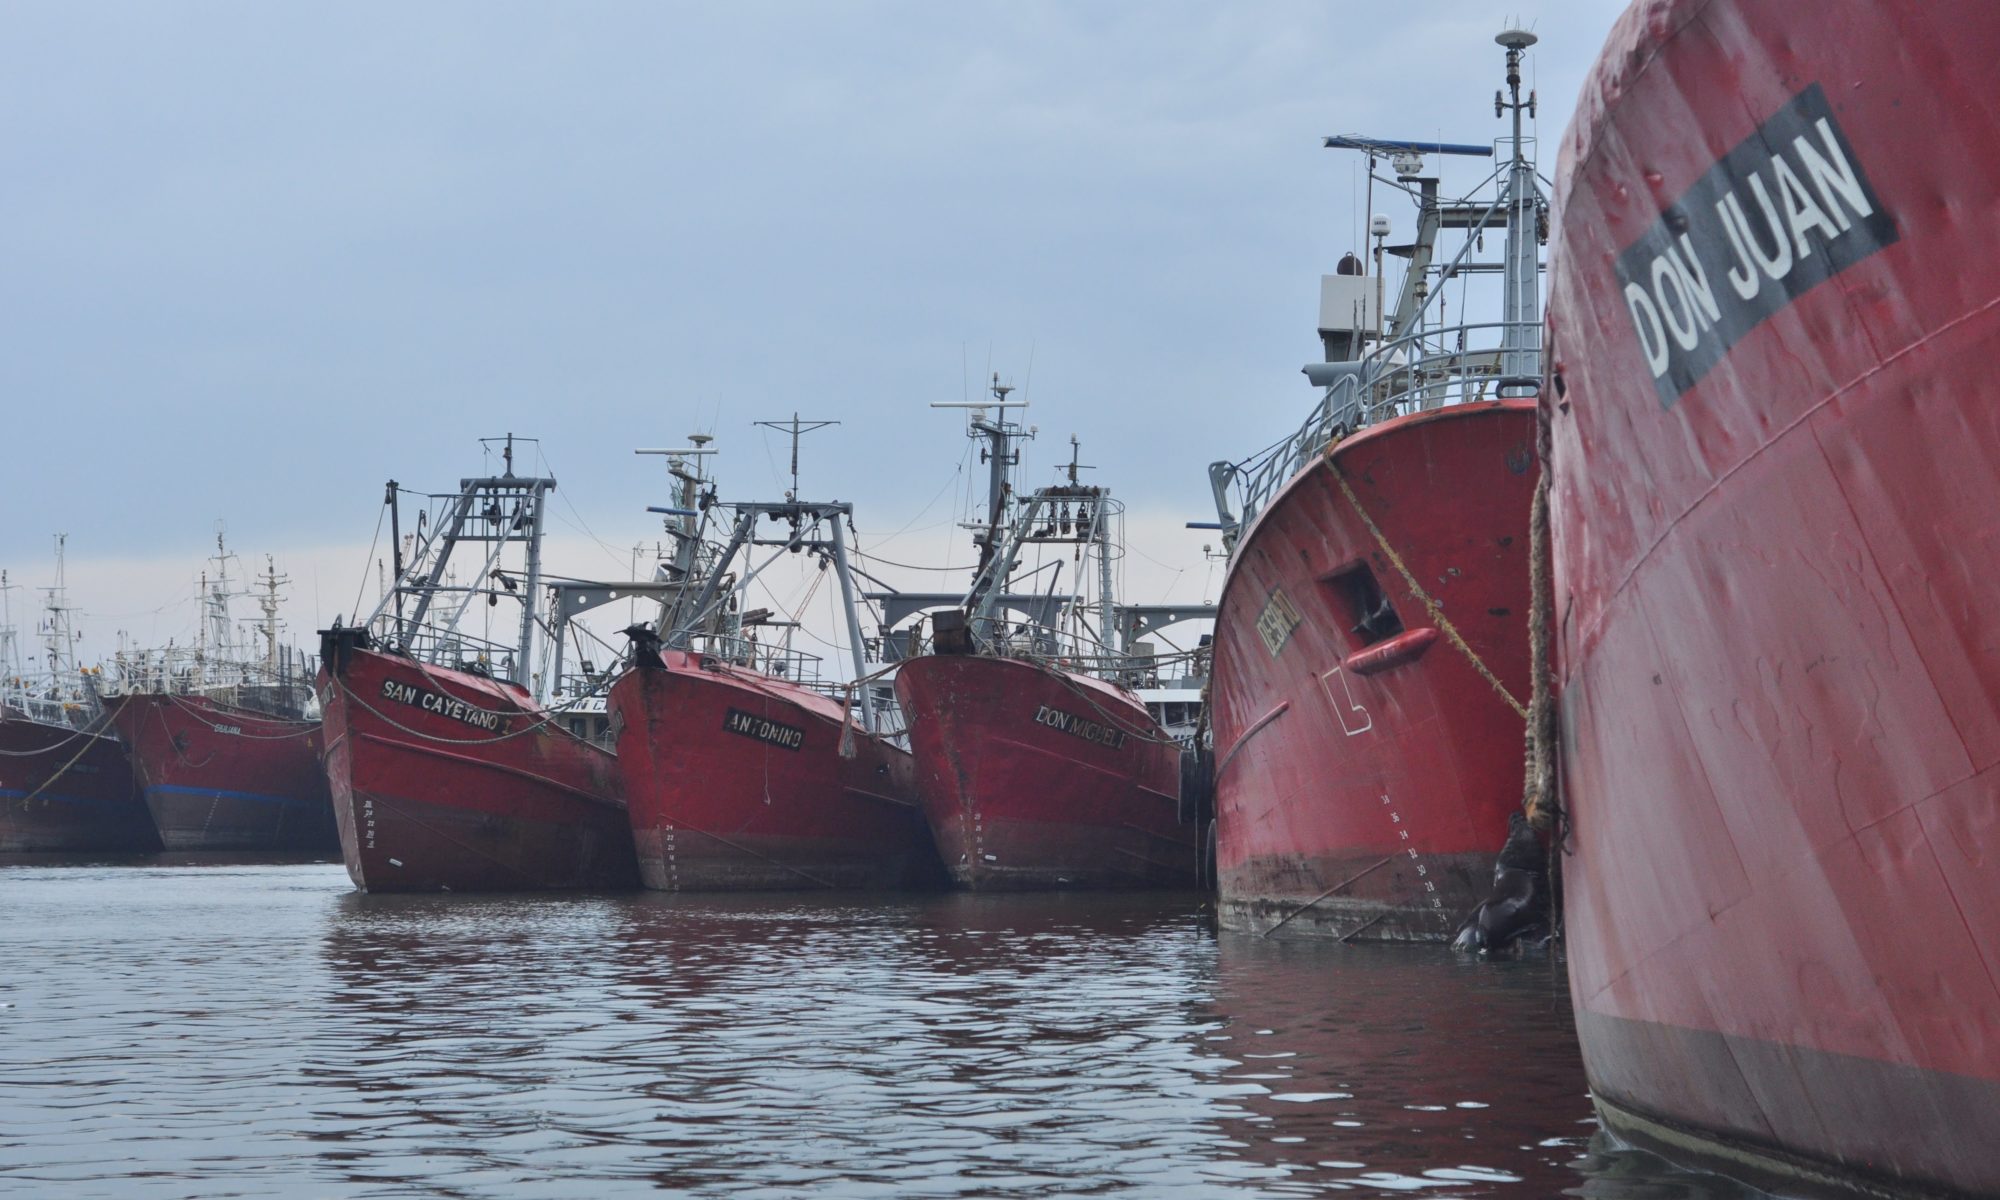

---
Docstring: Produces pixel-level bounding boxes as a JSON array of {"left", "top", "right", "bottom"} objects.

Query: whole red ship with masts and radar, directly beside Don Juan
[{"left": 1210, "top": 34, "right": 1542, "bottom": 940}]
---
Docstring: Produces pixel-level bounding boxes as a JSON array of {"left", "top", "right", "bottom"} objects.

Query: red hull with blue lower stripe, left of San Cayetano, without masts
[{"left": 112, "top": 694, "right": 340, "bottom": 852}]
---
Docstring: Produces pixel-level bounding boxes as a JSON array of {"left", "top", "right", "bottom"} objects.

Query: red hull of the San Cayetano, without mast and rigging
[{"left": 320, "top": 636, "right": 638, "bottom": 892}]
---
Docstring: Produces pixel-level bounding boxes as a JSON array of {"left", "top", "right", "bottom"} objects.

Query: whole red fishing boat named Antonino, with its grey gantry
[{"left": 610, "top": 460, "right": 936, "bottom": 892}]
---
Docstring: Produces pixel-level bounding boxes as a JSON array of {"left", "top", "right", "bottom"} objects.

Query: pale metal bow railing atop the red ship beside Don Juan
[{"left": 1208, "top": 320, "right": 1542, "bottom": 544}]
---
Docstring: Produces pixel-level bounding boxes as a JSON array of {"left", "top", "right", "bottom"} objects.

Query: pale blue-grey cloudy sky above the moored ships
[{"left": 0, "top": 0, "right": 1622, "bottom": 672}]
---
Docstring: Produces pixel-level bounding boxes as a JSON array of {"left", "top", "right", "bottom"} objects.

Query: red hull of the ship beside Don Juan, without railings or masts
[{"left": 1210, "top": 400, "right": 1536, "bottom": 940}]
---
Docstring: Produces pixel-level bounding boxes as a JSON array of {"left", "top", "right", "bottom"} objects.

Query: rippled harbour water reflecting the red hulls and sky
[{"left": 0, "top": 864, "right": 1736, "bottom": 1200}]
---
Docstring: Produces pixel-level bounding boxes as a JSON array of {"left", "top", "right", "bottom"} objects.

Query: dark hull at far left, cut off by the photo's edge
[{"left": 0, "top": 712, "right": 160, "bottom": 854}]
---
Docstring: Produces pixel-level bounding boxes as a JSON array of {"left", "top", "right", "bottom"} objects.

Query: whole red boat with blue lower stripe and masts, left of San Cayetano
[{"left": 104, "top": 532, "right": 340, "bottom": 854}]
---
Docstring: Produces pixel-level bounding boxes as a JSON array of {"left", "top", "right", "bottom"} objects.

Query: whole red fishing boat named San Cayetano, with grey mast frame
[{"left": 318, "top": 436, "right": 638, "bottom": 892}]
